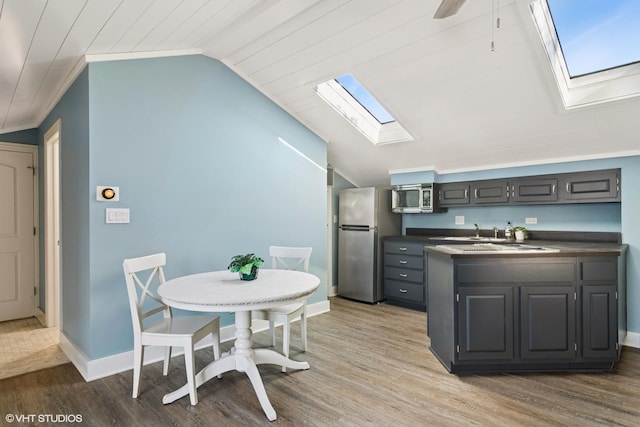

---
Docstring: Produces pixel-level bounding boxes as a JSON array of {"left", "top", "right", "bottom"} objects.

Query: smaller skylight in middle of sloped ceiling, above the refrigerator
[{"left": 315, "top": 74, "right": 413, "bottom": 145}]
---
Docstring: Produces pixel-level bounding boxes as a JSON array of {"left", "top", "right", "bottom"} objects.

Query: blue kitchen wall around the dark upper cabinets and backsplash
[{"left": 391, "top": 156, "right": 640, "bottom": 333}]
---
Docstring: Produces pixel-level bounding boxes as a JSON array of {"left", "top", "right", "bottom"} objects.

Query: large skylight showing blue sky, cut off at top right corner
[{"left": 529, "top": 0, "right": 640, "bottom": 109}]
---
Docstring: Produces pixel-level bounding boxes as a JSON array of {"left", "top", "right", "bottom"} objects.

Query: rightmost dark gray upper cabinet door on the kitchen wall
[{"left": 562, "top": 169, "right": 620, "bottom": 202}]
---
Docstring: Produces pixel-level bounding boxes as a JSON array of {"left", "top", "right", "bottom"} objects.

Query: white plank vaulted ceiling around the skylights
[{"left": 0, "top": 0, "right": 640, "bottom": 185}]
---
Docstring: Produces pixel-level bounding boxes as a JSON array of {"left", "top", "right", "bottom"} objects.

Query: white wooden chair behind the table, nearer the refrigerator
[{"left": 252, "top": 246, "right": 312, "bottom": 372}]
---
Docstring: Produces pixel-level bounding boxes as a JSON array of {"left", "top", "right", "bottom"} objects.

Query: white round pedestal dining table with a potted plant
[{"left": 158, "top": 269, "right": 320, "bottom": 421}]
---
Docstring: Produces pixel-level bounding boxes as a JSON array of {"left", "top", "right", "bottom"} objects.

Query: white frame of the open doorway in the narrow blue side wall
[{"left": 44, "top": 119, "right": 62, "bottom": 327}]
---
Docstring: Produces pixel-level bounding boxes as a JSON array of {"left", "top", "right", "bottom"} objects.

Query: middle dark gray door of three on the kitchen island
[{"left": 520, "top": 286, "right": 576, "bottom": 359}]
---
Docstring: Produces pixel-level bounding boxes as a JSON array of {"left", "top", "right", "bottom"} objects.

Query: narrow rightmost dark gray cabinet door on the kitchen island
[{"left": 582, "top": 285, "right": 618, "bottom": 358}]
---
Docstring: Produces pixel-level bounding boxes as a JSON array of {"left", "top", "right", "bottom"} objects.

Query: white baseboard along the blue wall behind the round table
[{"left": 60, "top": 300, "right": 331, "bottom": 381}]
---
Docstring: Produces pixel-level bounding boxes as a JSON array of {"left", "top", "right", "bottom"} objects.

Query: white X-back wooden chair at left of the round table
[{"left": 122, "top": 253, "right": 220, "bottom": 405}]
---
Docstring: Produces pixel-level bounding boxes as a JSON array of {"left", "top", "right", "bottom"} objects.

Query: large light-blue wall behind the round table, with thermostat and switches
[{"left": 38, "top": 56, "right": 327, "bottom": 359}]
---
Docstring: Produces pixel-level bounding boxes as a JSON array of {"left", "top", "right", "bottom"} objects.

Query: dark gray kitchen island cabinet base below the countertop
[{"left": 427, "top": 251, "right": 620, "bottom": 373}]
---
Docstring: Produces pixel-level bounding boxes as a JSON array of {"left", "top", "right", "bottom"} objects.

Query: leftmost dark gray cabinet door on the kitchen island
[{"left": 458, "top": 286, "right": 514, "bottom": 360}]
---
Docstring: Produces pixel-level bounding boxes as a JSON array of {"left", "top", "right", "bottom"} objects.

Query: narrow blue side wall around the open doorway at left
[{"left": 39, "top": 69, "right": 91, "bottom": 355}]
